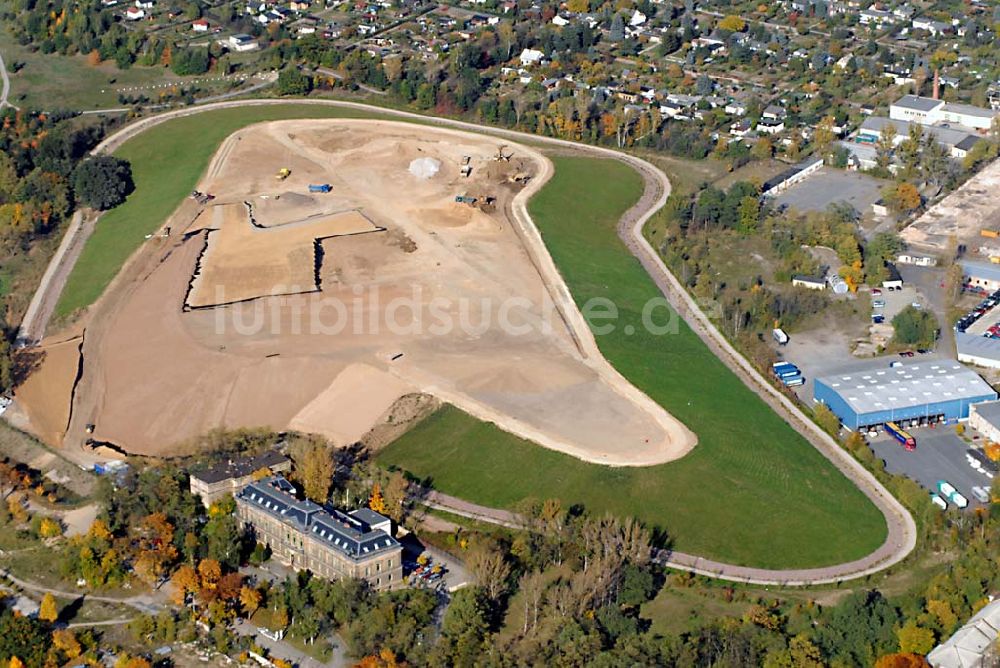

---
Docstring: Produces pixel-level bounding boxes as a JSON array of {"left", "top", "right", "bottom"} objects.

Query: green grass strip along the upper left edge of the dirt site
[{"left": 55, "top": 105, "right": 378, "bottom": 318}]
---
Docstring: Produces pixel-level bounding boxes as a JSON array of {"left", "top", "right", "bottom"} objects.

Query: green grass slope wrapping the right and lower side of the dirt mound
[{"left": 379, "top": 158, "right": 886, "bottom": 567}]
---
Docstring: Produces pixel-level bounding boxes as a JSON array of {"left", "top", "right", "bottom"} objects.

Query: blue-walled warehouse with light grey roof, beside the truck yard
[{"left": 813, "top": 360, "right": 997, "bottom": 430}]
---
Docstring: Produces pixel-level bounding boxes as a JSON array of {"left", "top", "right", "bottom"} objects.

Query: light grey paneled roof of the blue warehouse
[{"left": 816, "top": 360, "right": 996, "bottom": 415}]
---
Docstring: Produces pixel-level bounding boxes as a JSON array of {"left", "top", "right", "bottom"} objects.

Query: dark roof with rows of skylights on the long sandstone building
[{"left": 236, "top": 476, "right": 399, "bottom": 560}]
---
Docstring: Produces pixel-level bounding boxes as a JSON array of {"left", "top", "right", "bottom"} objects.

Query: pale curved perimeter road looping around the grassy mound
[{"left": 19, "top": 99, "right": 917, "bottom": 586}]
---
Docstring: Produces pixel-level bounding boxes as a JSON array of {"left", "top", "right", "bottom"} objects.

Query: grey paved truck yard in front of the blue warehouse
[{"left": 869, "top": 425, "right": 992, "bottom": 508}]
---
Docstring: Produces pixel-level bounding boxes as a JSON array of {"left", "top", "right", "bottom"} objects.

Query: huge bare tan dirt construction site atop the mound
[{"left": 25, "top": 120, "right": 696, "bottom": 466}]
